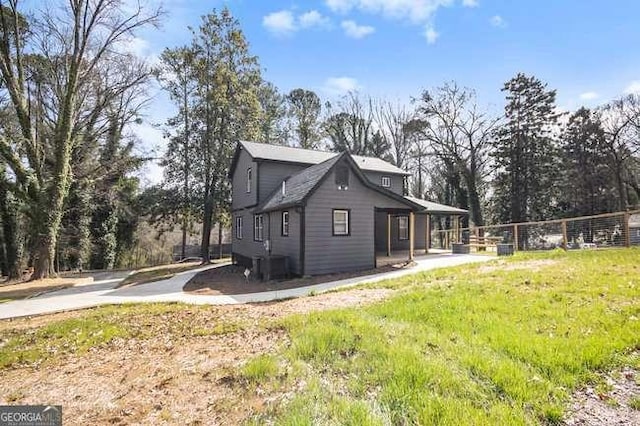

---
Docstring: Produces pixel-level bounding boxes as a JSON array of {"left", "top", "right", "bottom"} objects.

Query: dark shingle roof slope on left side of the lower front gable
[{"left": 257, "top": 153, "right": 343, "bottom": 212}]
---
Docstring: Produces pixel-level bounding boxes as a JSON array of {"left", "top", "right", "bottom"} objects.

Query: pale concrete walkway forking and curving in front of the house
[{"left": 0, "top": 254, "right": 494, "bottom": 319}]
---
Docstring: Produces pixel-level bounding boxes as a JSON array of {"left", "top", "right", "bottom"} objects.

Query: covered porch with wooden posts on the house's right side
[{"left": 375, "top": 197, "right": 468, "bottom": 267}]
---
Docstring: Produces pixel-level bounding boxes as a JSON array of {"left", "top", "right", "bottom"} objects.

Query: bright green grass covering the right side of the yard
[{"left": 244, "top": 249, "right": 640, "bottom": 425}]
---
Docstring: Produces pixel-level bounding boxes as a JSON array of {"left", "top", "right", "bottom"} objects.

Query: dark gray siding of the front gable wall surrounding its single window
[{"left": 304, "top": 163, "right": 407, "bottom": 275}]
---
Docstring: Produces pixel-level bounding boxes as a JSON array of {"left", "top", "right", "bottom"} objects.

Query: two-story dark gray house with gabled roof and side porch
[{"left": 229, "top": 142, "right": 467, "bottom": 275}]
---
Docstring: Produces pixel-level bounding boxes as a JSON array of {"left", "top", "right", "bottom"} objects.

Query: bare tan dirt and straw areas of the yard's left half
[{"left": 0, "top": 289, "right": 393, "bottom": 425}]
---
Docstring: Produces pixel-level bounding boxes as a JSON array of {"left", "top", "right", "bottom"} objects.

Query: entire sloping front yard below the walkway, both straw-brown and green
[{"left": 0, "top": 249, "right": 640, "bottom": 425}]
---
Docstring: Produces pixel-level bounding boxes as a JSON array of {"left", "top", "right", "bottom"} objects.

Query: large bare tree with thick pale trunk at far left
[{"left": 0, "top": 0, "right": 160, "bottom": 279}]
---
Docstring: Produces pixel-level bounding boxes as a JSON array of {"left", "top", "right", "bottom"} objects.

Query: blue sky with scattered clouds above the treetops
[{"left": 130, "top": 0, "right": 640, "bottom": 181}]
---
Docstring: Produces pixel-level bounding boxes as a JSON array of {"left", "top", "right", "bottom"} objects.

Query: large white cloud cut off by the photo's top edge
[{"left": 325, "top": 0, "right": 456, "bottom": 43}]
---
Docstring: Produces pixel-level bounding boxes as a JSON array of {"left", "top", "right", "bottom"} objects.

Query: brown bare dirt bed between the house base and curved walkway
[{"left": 183, "top": 263, "right": 407, "bottom": 295}]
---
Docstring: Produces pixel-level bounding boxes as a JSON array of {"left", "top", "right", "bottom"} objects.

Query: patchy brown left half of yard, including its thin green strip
[{"left": 0, "top": 289, "right": 393, "bottom": 425}]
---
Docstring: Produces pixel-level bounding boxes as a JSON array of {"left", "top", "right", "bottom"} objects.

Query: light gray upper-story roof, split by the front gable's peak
[{"left": 240, "top": 141, "right": 409, "bottom": 176}]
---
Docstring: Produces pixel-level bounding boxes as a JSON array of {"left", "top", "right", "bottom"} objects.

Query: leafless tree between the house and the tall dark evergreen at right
[{"left": 418, "top": 83, "right": 499, "bottom": 226}]
